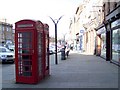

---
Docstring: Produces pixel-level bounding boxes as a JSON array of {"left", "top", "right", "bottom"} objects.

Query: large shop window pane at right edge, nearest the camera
[{"left": 111, "top": 19, "right": 120, "bottom": 65}]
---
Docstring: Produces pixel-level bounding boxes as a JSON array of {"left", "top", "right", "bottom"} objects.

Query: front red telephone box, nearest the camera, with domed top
[{"left": 15, "top": 20, "right": 49, "bottom": 84}]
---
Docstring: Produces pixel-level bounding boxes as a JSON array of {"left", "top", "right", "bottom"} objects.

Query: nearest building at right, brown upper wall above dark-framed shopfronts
[{"left": 96, "top": 1, "right": 120, "bottom": 65}]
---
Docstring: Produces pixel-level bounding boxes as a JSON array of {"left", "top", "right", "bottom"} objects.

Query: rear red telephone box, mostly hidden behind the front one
[{"left": 44, "top": 24, "right": 49, "bottom": 77}]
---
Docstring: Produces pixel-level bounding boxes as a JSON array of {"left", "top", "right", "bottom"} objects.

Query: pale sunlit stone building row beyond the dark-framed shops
[{"left": 70, "top": 0, "right": 104, "bottom": 54}]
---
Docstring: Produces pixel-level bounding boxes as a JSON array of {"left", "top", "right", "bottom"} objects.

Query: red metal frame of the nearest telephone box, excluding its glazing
[{"left": 15, "top": 20, "right": 46, "bottom": 84}]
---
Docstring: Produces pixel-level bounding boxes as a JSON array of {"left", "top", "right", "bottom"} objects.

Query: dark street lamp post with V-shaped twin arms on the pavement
[{"left": 49, "top": 15, "right": 63, "bottom": 64}]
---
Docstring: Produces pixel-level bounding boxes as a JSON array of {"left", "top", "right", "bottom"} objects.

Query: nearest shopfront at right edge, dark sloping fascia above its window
[{"left": 106, "top": 6, "right": 120, "bottom": 66}]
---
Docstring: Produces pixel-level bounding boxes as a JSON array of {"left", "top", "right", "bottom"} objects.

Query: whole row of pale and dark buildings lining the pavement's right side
[{"left": 70, "top": 0, "right": 120, "bottom": 65}]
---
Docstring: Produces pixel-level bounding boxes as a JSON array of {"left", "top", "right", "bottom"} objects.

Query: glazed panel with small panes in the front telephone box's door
[{"left": 18, "top": 32, "right": 33, "bottom": 76}]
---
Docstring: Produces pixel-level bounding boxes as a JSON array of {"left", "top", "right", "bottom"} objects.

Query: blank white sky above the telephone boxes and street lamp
[{"left": 0, "top": 0, "right": 83, "bottom": 37}]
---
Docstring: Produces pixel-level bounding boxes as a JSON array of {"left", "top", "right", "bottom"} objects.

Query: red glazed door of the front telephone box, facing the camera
[{"left": 15, "top": 30, "right": 36, "bottom": 83}]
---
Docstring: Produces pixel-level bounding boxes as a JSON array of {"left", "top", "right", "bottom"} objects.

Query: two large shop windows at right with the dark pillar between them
[{"left": 96, "top": 19, "right": 120, "bottom": 64}]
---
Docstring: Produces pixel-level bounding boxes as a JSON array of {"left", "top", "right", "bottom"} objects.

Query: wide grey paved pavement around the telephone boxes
[{"left": 2, "top": 51, "right": 119, "bottom": 90}]
